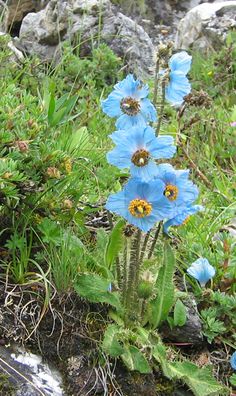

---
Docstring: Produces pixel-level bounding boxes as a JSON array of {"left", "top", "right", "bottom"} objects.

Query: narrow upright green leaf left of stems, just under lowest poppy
[{"left": 105, "top": 219, "right": 125, "bottom": 268}]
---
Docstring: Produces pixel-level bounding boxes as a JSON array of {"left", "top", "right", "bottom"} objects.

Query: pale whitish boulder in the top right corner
[{"left": 175, "top": 1, "right": 236, "bottom": 53}]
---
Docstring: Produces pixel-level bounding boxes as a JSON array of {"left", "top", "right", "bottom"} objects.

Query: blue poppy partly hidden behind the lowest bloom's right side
[{"left": 157, "top": 164, "right": 198, "bottom": 215}]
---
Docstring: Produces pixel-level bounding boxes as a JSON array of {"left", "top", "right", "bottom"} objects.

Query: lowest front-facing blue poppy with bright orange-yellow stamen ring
[{"left": 106, "top": 178, "right": 172, "bottom": 232}]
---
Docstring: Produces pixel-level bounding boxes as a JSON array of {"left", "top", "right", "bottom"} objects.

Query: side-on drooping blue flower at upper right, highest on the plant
[{"left": 165, "top": 51, "right": 192, "bottom": 106}]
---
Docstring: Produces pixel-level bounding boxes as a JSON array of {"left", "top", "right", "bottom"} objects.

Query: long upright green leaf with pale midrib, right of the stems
[{"left": 149, "top": 243, "right": 175, "bottom": 328}]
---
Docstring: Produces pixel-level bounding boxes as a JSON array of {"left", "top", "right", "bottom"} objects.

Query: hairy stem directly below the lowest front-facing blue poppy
[{"left": 125, "top": 230, "right": 141, "bottom": 317}]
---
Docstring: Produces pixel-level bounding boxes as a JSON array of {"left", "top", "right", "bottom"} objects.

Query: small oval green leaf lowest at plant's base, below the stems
[{"left": 121, "top": 345, "right": 152, "bottom": 374}]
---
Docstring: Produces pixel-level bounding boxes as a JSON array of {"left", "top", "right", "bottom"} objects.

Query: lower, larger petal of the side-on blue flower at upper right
[{"left": 166, "top": 71, "right": 191, "bottom": 106}]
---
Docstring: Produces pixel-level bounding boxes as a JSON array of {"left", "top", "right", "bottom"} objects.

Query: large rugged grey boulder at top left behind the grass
[{"left": 16, "top": 0, "right": 154, "bottom": 76}]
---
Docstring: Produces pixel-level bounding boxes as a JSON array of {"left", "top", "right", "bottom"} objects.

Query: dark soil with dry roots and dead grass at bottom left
[{"left": 0, "top": 284, "right": 195, "bottom": 396}]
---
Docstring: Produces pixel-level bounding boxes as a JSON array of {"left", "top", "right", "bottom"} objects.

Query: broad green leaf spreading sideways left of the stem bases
[{"left": 74, "top": 274, "right": 120, "bottom": 309}]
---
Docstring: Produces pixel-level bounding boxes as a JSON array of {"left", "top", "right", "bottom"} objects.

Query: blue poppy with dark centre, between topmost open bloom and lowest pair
[{"left": 107, "top": 127, "right": 176, "bottom": 180}]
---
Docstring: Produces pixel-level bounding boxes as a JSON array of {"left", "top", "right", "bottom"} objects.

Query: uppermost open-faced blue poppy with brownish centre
[{"left": 102, "top": 74, "right": 157, "bottom": 129}]
